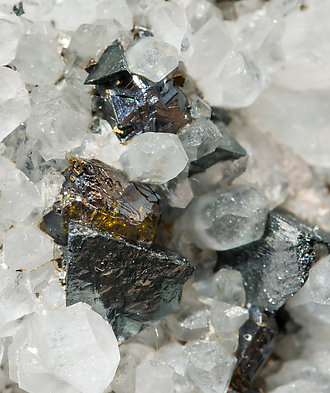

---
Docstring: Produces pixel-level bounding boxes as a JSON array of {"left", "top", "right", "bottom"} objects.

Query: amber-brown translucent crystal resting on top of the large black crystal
[{"left": 42, "top": 157, "right": 160, "bottom": 243}]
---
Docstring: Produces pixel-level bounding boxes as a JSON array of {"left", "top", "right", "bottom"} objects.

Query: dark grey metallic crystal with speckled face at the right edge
[{"left": 218, "top": 211, "right": 330, "bottom": 311}]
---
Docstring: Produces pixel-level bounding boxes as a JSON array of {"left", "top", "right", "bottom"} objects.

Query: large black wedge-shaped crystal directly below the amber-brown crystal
[{"left": 66, "top": 222, "right": 193, "bottom": 341}]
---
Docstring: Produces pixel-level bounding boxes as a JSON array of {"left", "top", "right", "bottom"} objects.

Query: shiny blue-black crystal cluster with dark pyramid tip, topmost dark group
[{"left": 85, "top": 41, "right": 190, "bottom": 141}]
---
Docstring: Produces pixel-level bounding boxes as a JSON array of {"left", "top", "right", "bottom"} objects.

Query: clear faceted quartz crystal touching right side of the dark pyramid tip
[{"left": 126, "top": 37, "right": 179, "bottom": 82}]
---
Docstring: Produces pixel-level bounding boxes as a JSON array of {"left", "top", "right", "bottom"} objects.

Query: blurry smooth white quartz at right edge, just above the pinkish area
[{"left": 246, "top": 86, "right": 330, "bottom": 168}]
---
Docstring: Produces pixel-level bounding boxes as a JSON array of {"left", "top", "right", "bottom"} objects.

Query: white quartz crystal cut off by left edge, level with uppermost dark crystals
[{"left": 0, "top": 67, "right": 31, "bottom": 140}]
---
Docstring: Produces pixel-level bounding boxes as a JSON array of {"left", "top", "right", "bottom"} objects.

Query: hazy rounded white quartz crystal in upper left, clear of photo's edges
[{"left": 13, "top": 34, "right": 64, "bottom": 85}]
